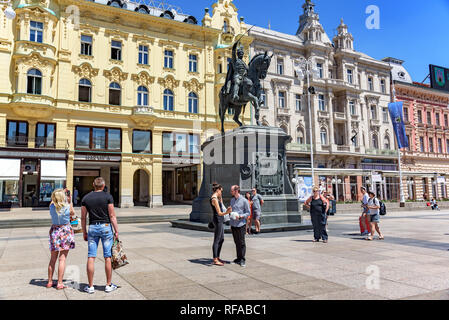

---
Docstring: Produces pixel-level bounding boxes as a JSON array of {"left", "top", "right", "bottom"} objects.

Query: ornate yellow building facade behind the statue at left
[{"left": 0, "top": 0, "right": 251, "bottom": 207}]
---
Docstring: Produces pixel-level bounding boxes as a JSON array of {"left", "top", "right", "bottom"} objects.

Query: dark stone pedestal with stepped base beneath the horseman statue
[{"left": 173, "top": 126, "right": 309, "bottom": 232}]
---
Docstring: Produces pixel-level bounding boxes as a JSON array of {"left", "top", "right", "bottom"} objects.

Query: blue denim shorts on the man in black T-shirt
[{"left": 87, "top": 223, "right": 114, "bottom": 258}]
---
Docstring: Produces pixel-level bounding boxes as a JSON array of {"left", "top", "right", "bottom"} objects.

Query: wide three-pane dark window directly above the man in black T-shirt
[{"left": 75, "top": 127, "right": 122, "bottom": 151}]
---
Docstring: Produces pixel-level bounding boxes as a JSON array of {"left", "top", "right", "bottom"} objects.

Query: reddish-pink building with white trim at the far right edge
[{"left": 385, "top": 58, "right": 449, "bottom": 200}]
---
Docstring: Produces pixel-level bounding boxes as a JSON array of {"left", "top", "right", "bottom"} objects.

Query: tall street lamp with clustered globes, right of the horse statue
[{"left": 295, "top": 57, "right": 320, "bottom": 185}]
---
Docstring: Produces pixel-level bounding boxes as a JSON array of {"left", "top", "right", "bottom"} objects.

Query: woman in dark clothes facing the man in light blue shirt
[{"left": 210, "top": 183, "right": 232, "bottom": 266}]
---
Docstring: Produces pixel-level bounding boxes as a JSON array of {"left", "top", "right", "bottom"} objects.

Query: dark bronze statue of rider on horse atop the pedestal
[{"left": 219, "top": 40, "right": 272, "bottom": 133}]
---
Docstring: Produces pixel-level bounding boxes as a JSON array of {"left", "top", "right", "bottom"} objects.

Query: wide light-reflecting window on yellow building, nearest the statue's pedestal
[{"left": 162, "top": 132, "right": 200, "bottom": 155}]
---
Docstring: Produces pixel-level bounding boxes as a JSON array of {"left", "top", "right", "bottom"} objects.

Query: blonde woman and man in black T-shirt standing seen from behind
[{"left": 46, "top": 177, "right": 118, "bottom": 294}]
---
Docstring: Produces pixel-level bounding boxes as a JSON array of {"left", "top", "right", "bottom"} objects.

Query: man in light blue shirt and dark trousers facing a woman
[{"left": 230, "top": 186, "right": 250, "bottom": 267}]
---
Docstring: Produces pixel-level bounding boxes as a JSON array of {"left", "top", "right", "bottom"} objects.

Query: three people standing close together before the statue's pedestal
[{"left": 210, "top": 183, "right": 263, "bottom": 267}]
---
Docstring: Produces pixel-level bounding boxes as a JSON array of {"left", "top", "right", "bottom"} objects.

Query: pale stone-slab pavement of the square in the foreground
[{"left": 0, "top": 211, "right": 449, "bottom": 300}]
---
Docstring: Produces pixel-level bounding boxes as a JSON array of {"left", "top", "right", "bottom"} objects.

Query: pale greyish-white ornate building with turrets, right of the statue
[{"left": 250, "top": 0, "right": 399, "bottom": 201}]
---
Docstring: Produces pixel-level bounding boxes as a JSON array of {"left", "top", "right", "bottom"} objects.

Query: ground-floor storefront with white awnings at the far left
[{"left": 0, "top": 150, "right": 67, "bottom": 208}]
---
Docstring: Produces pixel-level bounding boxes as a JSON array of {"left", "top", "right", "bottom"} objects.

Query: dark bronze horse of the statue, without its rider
[{"left": 219, "top": 52, "right": 272, "bottom": 133}]
